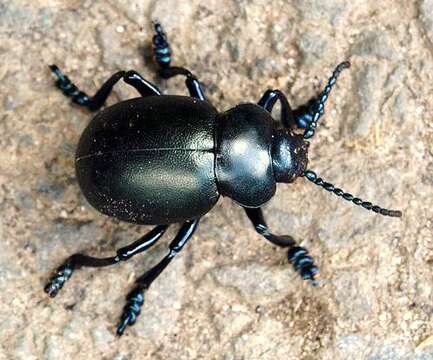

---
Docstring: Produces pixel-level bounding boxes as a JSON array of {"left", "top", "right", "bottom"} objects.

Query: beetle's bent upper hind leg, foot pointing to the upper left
[{"left": 49, "top": 65, "right": 161, "bottom": 111}]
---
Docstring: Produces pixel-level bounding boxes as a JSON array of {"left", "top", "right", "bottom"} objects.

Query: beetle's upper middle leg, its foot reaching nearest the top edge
[{"left": 152, "top": 23, "right": 206, "bottom": 100}]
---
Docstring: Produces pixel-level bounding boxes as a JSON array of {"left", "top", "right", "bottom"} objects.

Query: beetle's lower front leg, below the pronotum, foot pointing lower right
[{"left": 244, "top": 208, "right": 318, "bottom": 285}]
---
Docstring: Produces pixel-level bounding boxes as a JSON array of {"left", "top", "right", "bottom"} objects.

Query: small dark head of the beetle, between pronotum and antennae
[{"left": 271, "top": 129, "right": 310, "bottom": 183}]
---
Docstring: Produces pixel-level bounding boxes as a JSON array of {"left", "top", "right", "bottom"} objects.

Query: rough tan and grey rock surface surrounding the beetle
[{"left": 0, "top": 0, "right": 433, "bottom": 360}]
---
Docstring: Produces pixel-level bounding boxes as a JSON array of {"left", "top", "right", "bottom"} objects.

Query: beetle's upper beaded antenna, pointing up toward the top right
[{"left": 303, "top": 61, "right": 350, "bottom": 139}]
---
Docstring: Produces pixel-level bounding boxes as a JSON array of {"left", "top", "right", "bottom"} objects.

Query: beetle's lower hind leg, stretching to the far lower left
[{"left": 44, "top": 225, "right": 168, "bottom": 297}]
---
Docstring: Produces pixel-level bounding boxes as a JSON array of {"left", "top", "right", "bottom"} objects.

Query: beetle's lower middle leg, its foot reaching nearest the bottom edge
[{"left": 117, "top": 219, "right": 200, "bottom": 336}]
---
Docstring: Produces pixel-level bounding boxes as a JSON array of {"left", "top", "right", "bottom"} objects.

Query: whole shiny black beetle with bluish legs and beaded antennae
[{"left": 45, "top": 22, "right": 401, "bottom": 335}]
